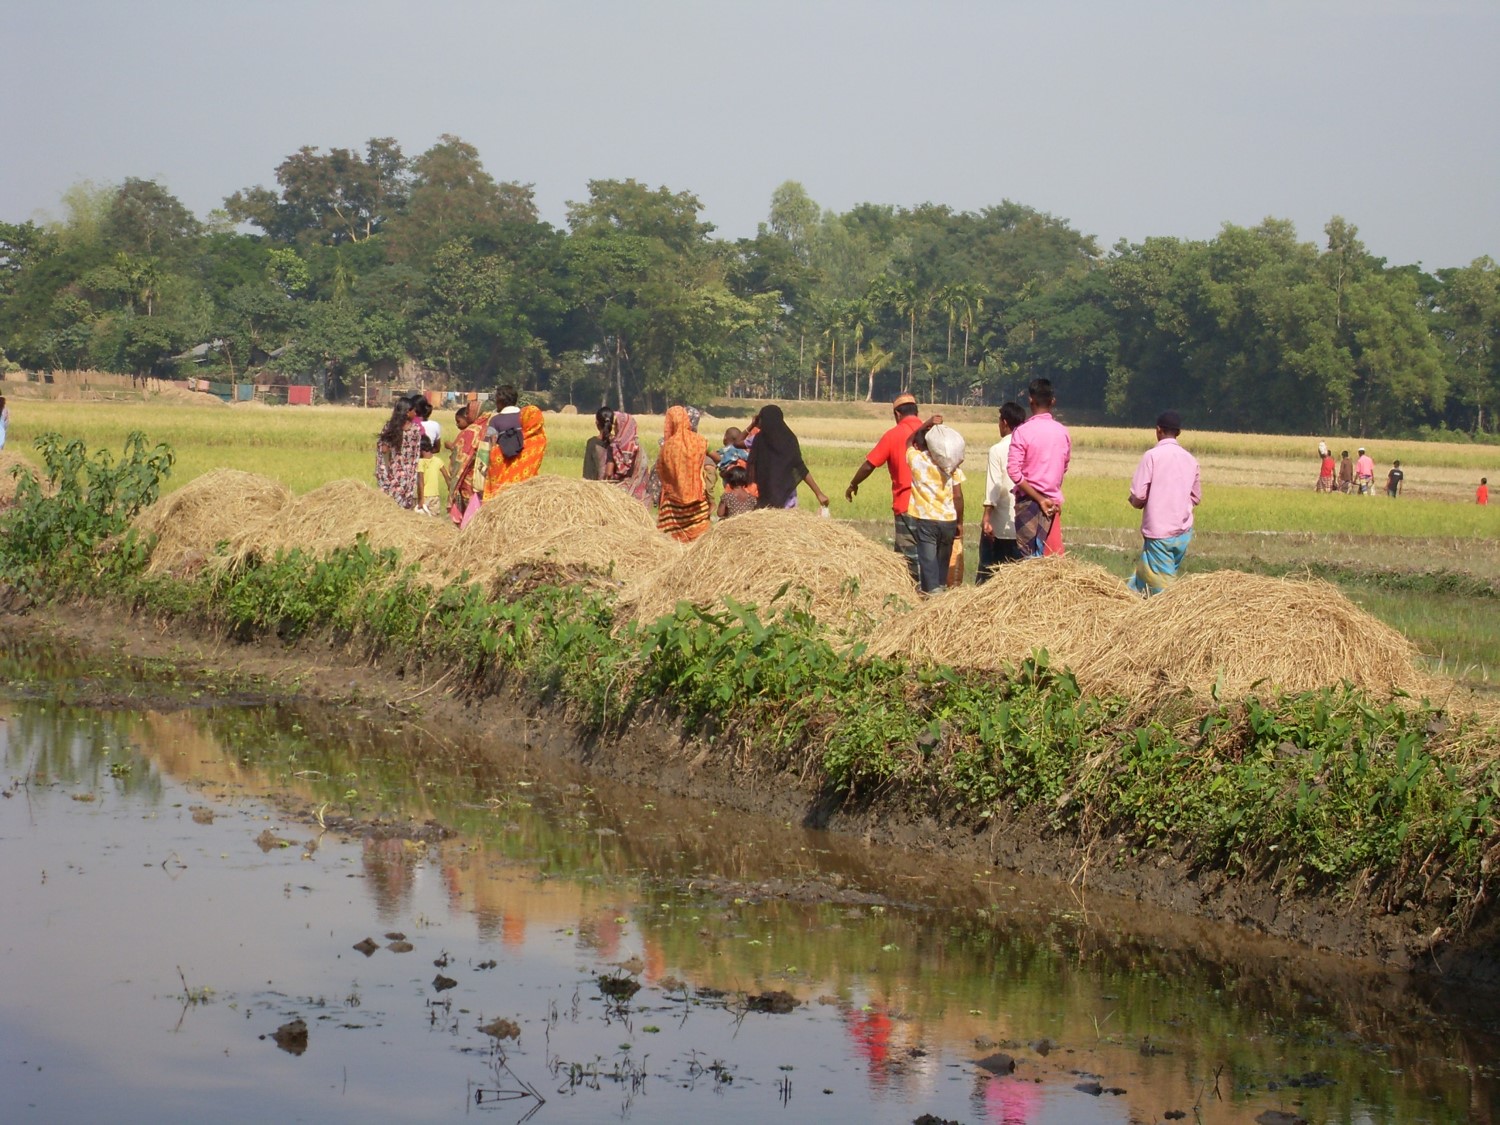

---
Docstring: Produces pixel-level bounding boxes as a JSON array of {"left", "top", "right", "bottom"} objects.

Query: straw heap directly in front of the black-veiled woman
[{"left": 621, "top": 510, "right": 917, "bottom": 626}]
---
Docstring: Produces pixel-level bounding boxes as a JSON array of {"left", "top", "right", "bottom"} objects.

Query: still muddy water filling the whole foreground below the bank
[{"left": 0, "top": 648, "right": 1500, "bottom": 1125}]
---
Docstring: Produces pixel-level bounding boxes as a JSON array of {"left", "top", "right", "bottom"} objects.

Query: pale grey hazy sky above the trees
[{"left": 0, "top": 0, "right": 1500, "bottom": 270}]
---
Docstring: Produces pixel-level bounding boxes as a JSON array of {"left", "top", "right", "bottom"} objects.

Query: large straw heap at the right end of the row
[{"left": 1128, "top": 570, "right": 1431, "bottom": 699}]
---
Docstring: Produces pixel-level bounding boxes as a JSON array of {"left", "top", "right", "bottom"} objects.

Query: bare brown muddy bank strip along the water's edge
[{"left": 0, "top": 603, "right": 1500, "bottom": 983}]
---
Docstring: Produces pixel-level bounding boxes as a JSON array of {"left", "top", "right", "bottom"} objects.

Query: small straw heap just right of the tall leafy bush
[{"left": 135, "top": 470, "right": 291, "bottom": 575}]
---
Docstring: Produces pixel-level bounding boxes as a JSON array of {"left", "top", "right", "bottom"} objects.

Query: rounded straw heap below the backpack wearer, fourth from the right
[{"left": 440, "top": 477, "right": 669, "bottom": 584}]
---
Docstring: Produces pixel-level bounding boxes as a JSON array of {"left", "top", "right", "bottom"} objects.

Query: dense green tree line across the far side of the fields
[{"left": 0, "top": 135, "right": 1500, "bottom": 435}]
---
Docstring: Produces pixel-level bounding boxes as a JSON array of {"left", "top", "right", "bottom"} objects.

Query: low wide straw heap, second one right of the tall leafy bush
[{"left": 228, "top": 480, "right": 455, "bottom": 578}]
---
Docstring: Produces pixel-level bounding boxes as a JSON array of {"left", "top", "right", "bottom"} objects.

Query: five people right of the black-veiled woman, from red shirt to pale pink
[{"left": 845, "top": 380, "right": 1203, "bottom": 596}]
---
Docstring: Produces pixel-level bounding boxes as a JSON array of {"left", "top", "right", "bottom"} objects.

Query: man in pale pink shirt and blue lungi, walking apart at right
[{"left": 1130, "top": 410, "right": 1206, "bottom": 597}]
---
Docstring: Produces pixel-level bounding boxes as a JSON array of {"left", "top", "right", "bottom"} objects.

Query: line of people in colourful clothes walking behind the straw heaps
[{"left": 375, "top": 380, "right": 1206, "bottom": 596}]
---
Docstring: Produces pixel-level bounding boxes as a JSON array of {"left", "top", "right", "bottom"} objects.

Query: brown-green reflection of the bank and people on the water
[{"left": 0, "top": 657, "right": 1500, "bottom": 1122}]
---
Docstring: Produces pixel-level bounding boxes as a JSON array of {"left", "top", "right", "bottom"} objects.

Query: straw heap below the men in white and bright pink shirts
[{"left": 870, "top": 557, "right": 1143, "bottom": 690}]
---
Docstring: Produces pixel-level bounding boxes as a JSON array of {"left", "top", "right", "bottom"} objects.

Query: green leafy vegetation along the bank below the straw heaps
[{"left": 0, "top": 440, "right": 1500, "bottom": 926}]
